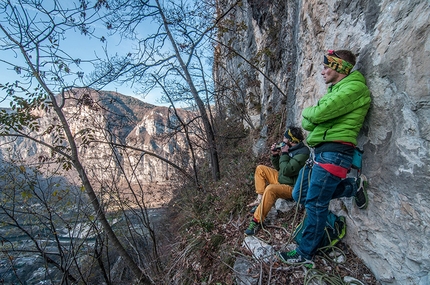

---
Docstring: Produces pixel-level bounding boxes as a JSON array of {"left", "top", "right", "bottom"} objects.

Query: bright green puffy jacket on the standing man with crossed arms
[{"left": 302, "top": 71, "right": 371, "bottom": 147}]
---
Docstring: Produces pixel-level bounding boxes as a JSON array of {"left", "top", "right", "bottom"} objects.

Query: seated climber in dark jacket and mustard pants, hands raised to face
[{"left": 245, "top": 126, "right": 309, "bottom": 235}]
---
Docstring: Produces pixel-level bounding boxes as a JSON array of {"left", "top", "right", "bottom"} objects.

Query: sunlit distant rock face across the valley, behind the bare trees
[{"left": 0, "top": 90, "right": 200, "bottom": 206}]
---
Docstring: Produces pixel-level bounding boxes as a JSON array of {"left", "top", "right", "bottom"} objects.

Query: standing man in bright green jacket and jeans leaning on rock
[{"left": 277, "top": 50, "right": 371, "bottom": 267}]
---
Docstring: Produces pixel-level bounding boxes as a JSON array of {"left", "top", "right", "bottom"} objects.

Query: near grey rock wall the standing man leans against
[{"left": 215, "top": 0, "right": 430, "bottom": 285}]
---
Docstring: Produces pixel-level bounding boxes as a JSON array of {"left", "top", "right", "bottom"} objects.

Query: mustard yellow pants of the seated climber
[{"left": 254, "top": 165, "right": 293, "bottom": 222}]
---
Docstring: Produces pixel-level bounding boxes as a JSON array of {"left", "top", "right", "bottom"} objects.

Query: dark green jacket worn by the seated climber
[{"left": 271, "top": 142, "right": 310, "bottom": 186}]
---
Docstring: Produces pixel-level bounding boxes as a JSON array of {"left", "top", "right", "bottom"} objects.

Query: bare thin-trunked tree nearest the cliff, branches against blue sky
[{"left": 88, "top": 0, "right": 235, "bottom": 180}]
